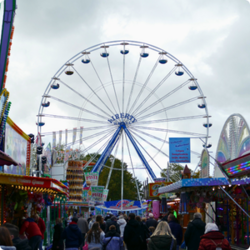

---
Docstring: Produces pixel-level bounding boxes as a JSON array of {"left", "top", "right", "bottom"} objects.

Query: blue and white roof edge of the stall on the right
[{"left": 158, "top": 178, "right": 250, "bottom": 194}]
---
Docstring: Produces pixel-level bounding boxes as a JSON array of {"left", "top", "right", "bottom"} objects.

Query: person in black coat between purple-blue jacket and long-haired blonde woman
[{"left": 123, "top": 213, "right": 147, "bottom": 250}]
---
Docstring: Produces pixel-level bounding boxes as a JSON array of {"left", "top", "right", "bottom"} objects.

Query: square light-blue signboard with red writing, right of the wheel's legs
[{"left": 169, "top": 138, "right": 191, "bottom": 163}]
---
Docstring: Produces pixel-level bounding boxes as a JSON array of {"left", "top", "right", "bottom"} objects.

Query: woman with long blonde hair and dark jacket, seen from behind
[{"left": 148, "top": 221, "right": 176, "bottom": 250}]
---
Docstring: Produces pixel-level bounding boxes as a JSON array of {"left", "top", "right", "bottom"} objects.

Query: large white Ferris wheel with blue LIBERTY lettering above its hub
[{"left": 37, "top": 40, "right": 212, "bottom": 188}]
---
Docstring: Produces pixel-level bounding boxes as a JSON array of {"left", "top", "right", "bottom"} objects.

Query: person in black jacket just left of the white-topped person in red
[{"left": 184, "top": 213, "right": 206, "bottom": 250}]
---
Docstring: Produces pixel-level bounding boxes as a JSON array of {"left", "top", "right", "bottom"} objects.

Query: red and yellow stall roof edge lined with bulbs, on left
[{"left": 0, "top": 173, "right": 68, "bottom": 196}]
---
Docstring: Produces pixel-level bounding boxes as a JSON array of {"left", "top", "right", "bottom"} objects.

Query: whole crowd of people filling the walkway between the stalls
[{"left": 0, "top": 212, "right": 231, "bottom": 250}]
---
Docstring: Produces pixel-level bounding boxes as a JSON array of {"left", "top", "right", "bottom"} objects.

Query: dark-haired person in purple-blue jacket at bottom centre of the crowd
[{"left": 103, "top": 225, "right": 124, "bottom": 250}]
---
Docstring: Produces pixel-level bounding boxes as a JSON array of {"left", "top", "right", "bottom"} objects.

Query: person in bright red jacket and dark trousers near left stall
[{"left": 19, "top": 215, "right": 42, "bottom": 250}]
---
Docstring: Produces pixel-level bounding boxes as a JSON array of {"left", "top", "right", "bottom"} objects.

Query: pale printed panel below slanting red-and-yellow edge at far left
[{"left": 4, "top": 123, "right": 28, "bottom": 175}]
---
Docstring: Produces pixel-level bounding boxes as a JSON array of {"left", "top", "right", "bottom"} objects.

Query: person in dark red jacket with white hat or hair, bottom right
[{"left": 198, "top": 223, "right": 232, "bottom": 250}]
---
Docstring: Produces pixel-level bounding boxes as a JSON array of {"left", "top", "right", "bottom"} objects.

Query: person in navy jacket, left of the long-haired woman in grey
[{"left": 62, "top": 217, "right": 82, "bottom": 250}]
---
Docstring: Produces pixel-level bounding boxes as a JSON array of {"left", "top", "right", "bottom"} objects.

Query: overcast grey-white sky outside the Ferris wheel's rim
[{"left": 6, "top": 0, "right": 250, "bottom": 180}]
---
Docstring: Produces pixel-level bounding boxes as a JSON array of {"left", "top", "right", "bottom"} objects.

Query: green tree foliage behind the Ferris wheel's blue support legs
[{"left": 84, "top": 155, "right": 142, "bottom": 200}]
